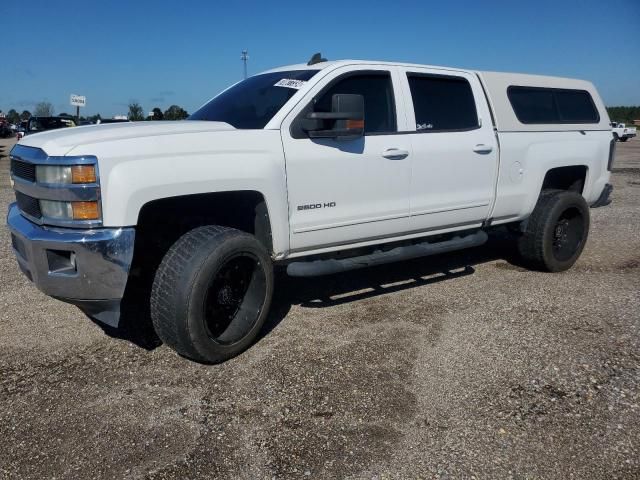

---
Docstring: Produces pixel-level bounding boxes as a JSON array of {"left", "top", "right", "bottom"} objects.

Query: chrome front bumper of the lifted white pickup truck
[{"left": 7, "top": 203, "right": 135, "bottom": 326}]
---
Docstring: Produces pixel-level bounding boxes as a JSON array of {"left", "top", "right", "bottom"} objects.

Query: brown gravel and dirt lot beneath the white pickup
[{"left": 0, "top": 139, "right": 640, "bottom": 479}]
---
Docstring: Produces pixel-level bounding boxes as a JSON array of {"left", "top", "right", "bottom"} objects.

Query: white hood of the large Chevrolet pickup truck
[{"left": 20, "top": 120, "right": 235, "bottom": 156}]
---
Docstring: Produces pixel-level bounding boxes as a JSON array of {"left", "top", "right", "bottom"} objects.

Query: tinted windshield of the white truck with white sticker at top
[{"left": 188, "top": 70, "right": 318, "bottom": 129}]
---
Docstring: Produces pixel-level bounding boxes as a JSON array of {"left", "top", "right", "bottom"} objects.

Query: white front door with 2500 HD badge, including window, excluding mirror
[{"left": 282, "top": 65, "right": 411, "bottom": 252}]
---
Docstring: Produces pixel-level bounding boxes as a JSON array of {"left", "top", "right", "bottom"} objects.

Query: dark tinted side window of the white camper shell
[{"left": 507, "top": 86, "right": 600, "bottom": 124}]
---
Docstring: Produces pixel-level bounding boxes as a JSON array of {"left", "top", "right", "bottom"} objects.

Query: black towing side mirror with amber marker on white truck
[{"left": 301, "top": 93, "right": 364, "bottom": 140}]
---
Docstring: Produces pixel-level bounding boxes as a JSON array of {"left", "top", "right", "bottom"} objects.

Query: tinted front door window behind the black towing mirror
[{"left": 313, "top": 72, "right": 397, "bottom": 135}]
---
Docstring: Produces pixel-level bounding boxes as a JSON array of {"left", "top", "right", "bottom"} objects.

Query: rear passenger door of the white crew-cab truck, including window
[{"left": 401, "top": 67, "right": 498, "bottom": 231}]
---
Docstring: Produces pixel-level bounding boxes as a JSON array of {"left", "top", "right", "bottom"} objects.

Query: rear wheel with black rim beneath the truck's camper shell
[{"left": 518, "top": 190, "right": 589, "bottom": 272}]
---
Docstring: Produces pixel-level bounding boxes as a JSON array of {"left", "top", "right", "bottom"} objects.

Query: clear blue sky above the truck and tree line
[{"left": 0, "top": 0, "right": 640, "bottom": 116}]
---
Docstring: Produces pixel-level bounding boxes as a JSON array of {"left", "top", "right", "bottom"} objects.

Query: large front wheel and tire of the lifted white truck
[{"left": 151, "top": 225, "right": 273, "bottom": 363}]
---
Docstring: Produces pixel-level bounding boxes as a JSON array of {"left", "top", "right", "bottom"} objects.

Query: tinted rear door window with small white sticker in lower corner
[{"left": 407, "top": 73, "right": 478, "bottom": 132}]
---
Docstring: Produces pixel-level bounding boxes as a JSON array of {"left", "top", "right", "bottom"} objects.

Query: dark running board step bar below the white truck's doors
[{"left": 287, "top": 230, "right": 489, "bottom": 277}]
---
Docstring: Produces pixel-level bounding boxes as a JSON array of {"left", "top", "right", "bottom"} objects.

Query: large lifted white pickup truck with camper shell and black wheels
[{"left": 8, "top": 57, "right": 615, "bottom": 363}]
